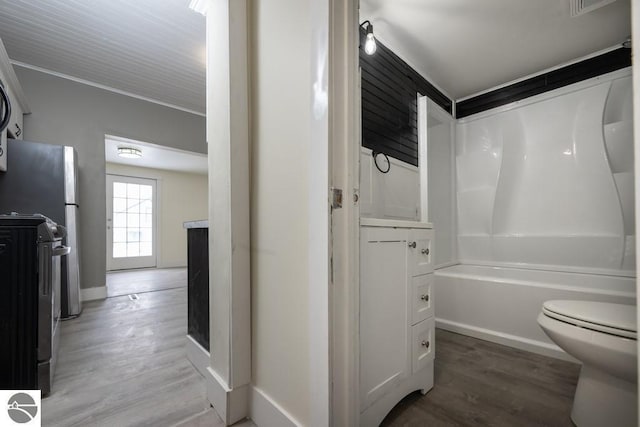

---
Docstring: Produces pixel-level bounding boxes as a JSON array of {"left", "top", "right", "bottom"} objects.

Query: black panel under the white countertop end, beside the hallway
[{"left": 187, "top": 228, "right": 209, "bottom": 351}]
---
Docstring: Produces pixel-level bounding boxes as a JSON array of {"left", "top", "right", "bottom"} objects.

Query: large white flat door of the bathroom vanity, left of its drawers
[{"left": 360, "top": 227, "right": 411, "bottom": 411}]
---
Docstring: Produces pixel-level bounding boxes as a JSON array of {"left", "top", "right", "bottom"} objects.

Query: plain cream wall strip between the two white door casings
[{"left": 250, "top": 0, "right": 312, "bottom": 425}]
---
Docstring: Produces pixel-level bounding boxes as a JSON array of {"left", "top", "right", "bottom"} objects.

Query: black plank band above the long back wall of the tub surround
[{"left": 456, "top": 48, "right": 631, "bottom": 118}]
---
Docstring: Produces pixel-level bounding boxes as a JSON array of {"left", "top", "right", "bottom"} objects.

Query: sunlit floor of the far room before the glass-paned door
[{"left": 107, "top": 268, "right": 187, "bottom": 297}]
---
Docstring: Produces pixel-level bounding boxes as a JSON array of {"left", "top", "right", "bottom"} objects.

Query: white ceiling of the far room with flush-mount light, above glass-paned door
[{"left": 104, "top": 135, "right": 208, "bottom": 174}]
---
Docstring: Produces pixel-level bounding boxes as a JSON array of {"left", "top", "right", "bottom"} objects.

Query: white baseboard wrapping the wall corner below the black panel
[{"left": 185, "top": 335, "right": 250, "bottom": 426}]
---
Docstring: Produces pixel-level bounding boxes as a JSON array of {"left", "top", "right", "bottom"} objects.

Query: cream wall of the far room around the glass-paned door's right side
[{"left": 106, "top": 163, "right": 208, "bottom": 268}]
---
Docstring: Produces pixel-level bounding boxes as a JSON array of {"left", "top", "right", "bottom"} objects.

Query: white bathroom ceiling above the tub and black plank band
[{"left": 360, "top": 0, "right": 631, "bottom": 99}]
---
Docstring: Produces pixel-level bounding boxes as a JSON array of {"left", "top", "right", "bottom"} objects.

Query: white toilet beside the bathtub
[{"left": 538, "top": 300, "right": 638, "bottom": 427}]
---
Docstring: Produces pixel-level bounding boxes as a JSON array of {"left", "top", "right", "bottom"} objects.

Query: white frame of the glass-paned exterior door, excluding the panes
[{"left": 105, "top": 173, "right": 160, "bottom": 271}]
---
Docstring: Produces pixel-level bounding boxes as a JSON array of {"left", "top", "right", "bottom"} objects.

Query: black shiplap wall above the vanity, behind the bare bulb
[{"left": 360, "top": 28, "right": 453, "bottom": 166}]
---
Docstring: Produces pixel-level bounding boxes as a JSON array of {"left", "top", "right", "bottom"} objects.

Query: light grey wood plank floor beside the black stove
[{"left": 42, "top": 272, "right": 253, "bottom": 427}]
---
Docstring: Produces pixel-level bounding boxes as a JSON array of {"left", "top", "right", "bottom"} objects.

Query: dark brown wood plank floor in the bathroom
[{"left": 382, "top": 329, "right": 580, "bottom": 427}]
